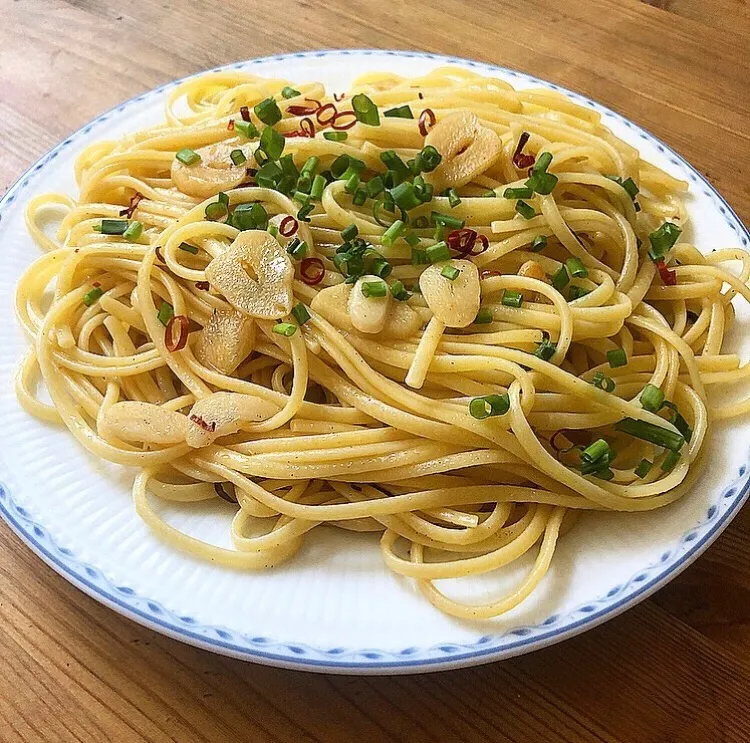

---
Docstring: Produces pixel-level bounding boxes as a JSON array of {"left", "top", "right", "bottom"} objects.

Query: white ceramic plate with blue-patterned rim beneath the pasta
[{"left": 0, "top": 50, "right": 750, "bottom": 673}]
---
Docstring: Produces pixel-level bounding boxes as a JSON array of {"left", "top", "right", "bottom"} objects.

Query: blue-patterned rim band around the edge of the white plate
[{"left": 0, "top": 49, "right": 750, "bottom": 673}]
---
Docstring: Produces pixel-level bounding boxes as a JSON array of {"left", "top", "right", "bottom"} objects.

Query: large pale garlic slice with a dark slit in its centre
[{"left": 206, "top": 230, "right": 294, "bottom": 320}]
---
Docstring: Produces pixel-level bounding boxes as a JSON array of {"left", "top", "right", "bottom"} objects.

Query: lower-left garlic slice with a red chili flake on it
[{"left": 185, "top": 392, "right": 279, "bottom": 449}]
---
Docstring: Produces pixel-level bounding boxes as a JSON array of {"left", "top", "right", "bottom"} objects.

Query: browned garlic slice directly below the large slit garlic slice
[{"left": 193, "top": 309, "right": 255, "bottom": 374}]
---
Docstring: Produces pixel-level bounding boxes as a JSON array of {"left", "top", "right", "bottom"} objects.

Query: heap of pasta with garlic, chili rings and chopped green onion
[{"left": 17, "top": 67, "right": 750, "bottom": 619}]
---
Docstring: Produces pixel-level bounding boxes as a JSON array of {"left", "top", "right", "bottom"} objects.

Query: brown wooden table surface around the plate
[{"left": 0, "top": 0, "right": 750, "bottom": 743}]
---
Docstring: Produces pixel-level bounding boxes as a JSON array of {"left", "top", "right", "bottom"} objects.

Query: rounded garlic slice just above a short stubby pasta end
[{"left": 419, "top": 260, "right": 480, "bottom": 328}]
